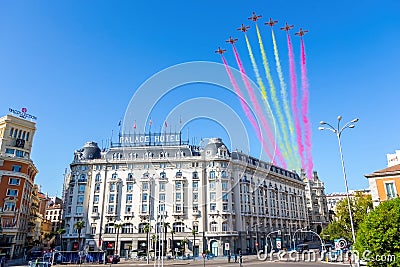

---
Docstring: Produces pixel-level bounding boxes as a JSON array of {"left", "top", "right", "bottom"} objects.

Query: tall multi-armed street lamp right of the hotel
[{"left": 318, "top": 116, "right": 358, "bottom": 244}]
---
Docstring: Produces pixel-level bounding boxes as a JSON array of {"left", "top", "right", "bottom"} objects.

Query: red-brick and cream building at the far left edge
[{"left": 0, "top": 115, "right": 38, "bottom": 257}]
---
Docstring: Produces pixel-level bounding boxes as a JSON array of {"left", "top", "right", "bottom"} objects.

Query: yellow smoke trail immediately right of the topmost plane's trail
[{"left": 271, "top": 28, "right": 300, "bottom": 169}]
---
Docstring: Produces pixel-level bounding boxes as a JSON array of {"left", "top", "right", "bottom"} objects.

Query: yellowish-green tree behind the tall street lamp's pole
[{"left": 321, "top": 192, "right": 373, "bottom": 243}]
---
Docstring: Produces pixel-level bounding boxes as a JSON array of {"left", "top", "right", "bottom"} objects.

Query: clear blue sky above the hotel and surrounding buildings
[{"left": 0, "top": 0, "right": 400, "bottom": 195}]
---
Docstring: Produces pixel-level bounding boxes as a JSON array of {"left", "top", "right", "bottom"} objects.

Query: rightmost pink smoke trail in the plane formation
[{"left": 301, "top": 38, "right": 313, "bottom": 179}]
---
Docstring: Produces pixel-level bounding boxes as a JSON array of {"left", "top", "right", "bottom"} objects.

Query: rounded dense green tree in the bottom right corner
[{"left": 356, "top": 198, "right": 400, "bottom": 266}]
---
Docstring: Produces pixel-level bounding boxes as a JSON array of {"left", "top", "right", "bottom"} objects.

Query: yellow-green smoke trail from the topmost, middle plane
[{"left": 256, "top": 24, "right": 295, "bottom": 168}]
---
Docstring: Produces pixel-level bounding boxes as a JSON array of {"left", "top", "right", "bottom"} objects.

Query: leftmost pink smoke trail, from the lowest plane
[{"left": 221, "top": 55, "right": 274, "bottom": 162}]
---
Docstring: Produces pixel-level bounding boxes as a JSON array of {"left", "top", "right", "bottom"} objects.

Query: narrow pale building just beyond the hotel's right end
[{"left": 302, "top": 171, "right": 329, "bottom": 234}]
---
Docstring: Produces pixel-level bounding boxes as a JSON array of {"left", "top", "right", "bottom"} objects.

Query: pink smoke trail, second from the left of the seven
[{"left": 232, "top": 45, "right": 286, "bottom": 168}]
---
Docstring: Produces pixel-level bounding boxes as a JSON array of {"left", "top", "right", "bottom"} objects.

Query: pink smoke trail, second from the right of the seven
[{"left": 287, "top": 33, "right": 304, "bottom": 174}]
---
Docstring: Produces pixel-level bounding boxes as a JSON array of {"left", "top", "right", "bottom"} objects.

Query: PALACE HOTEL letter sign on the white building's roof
[{"left": 115, "top": 133, "right": 186, "bottom": 146}]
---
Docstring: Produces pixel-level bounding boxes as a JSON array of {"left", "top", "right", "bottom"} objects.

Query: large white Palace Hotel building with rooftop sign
[{"left": 63, "top": 133, "right": 308, "bottom": 256}]
